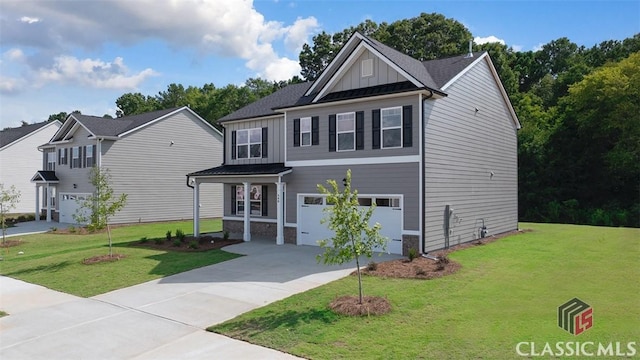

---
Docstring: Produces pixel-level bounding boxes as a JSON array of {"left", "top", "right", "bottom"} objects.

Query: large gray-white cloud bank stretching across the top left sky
[{"left": 0, "top": 0, "right": 318, "bottom": 80}]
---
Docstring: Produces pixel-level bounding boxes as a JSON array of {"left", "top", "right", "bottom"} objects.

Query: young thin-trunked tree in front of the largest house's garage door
[{"left": 317, "top": 169, "right": 387, "bottom": 304}]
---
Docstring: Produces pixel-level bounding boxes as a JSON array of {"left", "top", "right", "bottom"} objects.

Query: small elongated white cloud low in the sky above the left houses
[{"left": 34, "top": 56, "right": 156, "bottom": 89}]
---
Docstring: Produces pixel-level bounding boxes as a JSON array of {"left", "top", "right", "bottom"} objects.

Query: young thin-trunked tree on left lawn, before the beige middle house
[{"left": 73, "top": 166, "right": 127, "bottom": 256}]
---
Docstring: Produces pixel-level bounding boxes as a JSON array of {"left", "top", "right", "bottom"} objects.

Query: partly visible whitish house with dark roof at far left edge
[{"left": 0, "top": 120, "right": 61, "bottom": 214}]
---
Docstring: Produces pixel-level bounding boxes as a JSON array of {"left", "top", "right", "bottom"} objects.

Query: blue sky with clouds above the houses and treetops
[{"left": 0, "top": 0, "right": 640, "bottom": 129}]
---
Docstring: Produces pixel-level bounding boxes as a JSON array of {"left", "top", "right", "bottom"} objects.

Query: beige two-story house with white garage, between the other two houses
[{"left": 32, "top": 107, "right": 223, "bottom": 223}]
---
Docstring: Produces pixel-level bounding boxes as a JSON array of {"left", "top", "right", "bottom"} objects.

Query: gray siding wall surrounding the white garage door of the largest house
[{"left": 283, "top": 163, "right": 420, "bottom": 230}]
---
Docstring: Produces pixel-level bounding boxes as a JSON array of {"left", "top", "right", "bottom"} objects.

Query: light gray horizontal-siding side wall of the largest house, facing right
[{"left": 424, "top": 60, "right": 518, "bottom": 251}]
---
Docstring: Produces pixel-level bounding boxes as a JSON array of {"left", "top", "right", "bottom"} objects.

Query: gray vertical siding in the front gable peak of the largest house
[{"left": 330, "top": 50, "right": 407, "bottom": 92}]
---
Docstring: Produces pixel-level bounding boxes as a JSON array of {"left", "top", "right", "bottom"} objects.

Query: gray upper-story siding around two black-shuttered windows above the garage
[{"left": 286, "top": 95, "right": 420, "bottom": 161}]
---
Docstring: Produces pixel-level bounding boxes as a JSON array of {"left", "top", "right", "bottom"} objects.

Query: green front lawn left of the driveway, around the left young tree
[{"left": 0, "top": 219, "right": 240, "bottom": 297}]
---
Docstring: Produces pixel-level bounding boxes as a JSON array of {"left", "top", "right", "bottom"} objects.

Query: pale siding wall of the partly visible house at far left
[{"left": 0, "top": 123, "right": 60, "bottom": 213}]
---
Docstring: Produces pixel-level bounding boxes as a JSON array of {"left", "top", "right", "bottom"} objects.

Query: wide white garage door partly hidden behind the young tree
[{"left": 297, "top": 195, "right": 402, "bottom": 254}]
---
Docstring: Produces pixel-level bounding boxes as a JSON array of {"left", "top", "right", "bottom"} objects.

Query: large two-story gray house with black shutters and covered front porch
[{"left": 188, "top": 33, "right": 520, "bottom": 254}]
